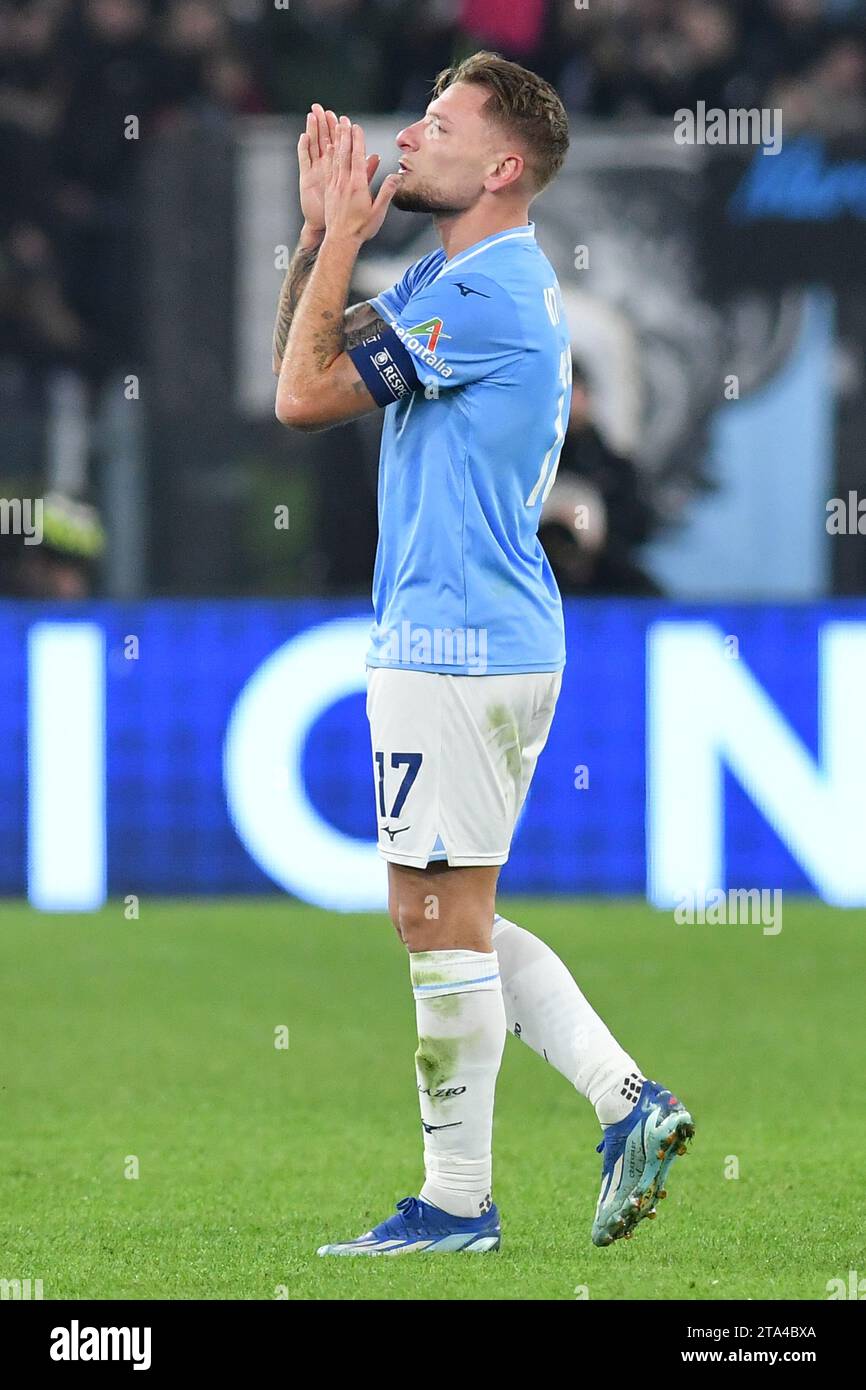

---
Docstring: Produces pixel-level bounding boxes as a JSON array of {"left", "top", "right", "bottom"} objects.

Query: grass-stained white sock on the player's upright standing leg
[{"left": 409, "top": 951, "right": 506, "bottom": 1216}]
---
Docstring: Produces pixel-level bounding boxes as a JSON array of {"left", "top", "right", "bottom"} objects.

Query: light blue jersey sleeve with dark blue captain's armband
[{"left": 350, "top": 272, "right": 527, "bottom": 406}]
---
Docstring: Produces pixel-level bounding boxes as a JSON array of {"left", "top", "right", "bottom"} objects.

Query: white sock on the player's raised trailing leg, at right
[{"left": 493, "top": 913, "right": 644, "bottom": 1125}]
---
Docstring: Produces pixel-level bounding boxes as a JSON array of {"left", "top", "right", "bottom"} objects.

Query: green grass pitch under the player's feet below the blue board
[{"left": 0, "top": 899, "right": 866, "bottom": 1301}]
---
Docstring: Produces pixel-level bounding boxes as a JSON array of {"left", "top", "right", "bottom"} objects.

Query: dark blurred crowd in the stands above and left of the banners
[{"left": 0, "top": 0, "right": 866, "bottom": 592}]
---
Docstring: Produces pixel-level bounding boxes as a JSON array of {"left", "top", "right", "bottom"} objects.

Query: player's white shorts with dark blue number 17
[{"left": 367, "top": 667, "right": 562, "bottom": 869}]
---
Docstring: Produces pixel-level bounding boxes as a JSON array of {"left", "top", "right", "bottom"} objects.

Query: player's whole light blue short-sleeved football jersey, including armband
[{"left": 350, "top": 222, "right": 571, "bottom": 676}]
